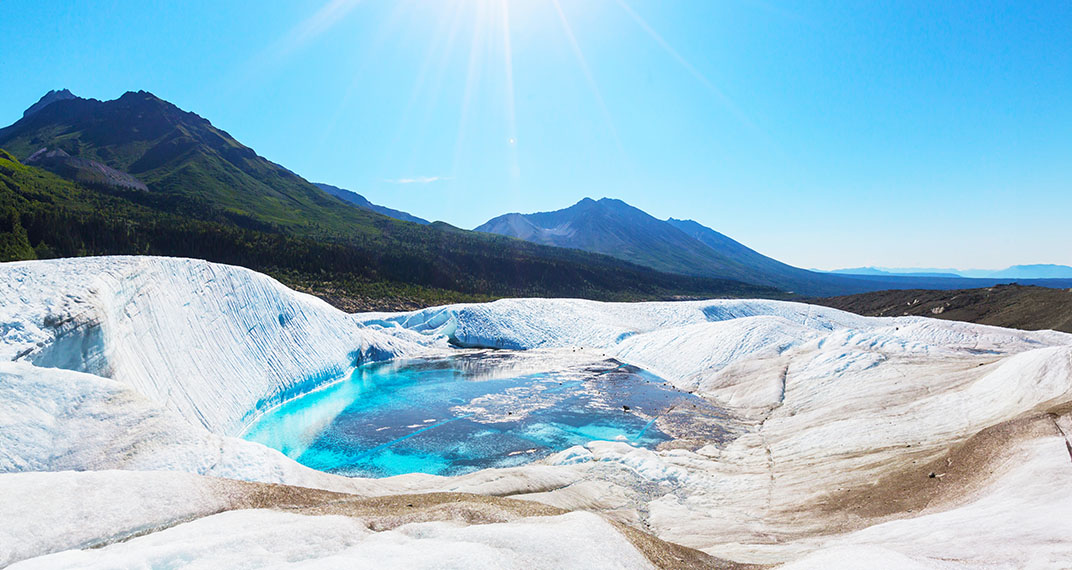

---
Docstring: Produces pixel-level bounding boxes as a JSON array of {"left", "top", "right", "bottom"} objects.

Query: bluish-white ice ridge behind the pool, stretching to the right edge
[{"left": 355, "top": 299, "right": 1072, "bottom": 390}]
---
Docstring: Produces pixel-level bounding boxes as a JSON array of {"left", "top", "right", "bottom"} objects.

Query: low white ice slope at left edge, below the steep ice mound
[{"left": 0, "top": 362, "right": 364, "bottom": 490}]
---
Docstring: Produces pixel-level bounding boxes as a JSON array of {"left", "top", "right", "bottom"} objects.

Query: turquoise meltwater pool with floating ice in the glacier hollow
[{"left": 244, "top": 353, "right": 711, "bottom": 477}]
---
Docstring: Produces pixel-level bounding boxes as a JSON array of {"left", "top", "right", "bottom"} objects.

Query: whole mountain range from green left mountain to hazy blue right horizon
[{"left": 0, "top": 90, "right": 1072, "bottom": 310}]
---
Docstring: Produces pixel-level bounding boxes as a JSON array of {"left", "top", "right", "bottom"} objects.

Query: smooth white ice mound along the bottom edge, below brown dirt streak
[{"left": 11, "top": 510, "right": 652, "bottom": 570}]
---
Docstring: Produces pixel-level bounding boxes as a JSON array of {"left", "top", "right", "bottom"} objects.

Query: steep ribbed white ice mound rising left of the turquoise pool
[{"left": 0, "top": 257, "right": 412, "bottom": 434}]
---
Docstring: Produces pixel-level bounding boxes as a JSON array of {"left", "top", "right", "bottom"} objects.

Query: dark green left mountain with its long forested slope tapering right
[{"left": 0, "top": 91, "right": 783, "bottom": 310}]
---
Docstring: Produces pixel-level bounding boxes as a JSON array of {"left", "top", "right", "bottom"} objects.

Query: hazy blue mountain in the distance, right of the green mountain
[{"left": 476, "top": 198, "right": 881, "bottom": 295}]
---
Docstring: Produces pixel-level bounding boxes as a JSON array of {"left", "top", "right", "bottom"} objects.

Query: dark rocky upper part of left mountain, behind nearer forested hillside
[{"left": 0, "top": 91, "right": 381, "bottom": 234}]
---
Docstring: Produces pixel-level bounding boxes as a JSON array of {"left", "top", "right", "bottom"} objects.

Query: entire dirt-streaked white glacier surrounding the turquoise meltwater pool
[{"left": 0, "top": 256, "right": 1072, "bottom": 568}]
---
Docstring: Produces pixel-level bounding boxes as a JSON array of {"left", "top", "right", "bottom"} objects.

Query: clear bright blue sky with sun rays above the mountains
[{"left": 0, "top": 0, "right": 1072, "bottom": 268}]
